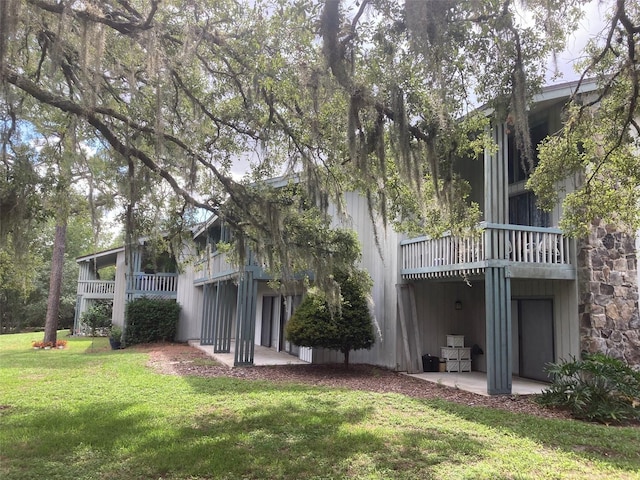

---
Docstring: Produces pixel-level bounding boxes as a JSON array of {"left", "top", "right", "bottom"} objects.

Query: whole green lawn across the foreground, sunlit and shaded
[{"left": 0, "top": 334, "right": 640, "bottom": 480}]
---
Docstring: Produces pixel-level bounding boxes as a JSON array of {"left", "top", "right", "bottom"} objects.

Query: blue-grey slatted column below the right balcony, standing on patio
[{"left": 485, "top": 267, "right": 513, "bottom": 395}]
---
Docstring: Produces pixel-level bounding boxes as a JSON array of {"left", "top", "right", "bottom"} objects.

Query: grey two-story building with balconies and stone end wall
[{"left": 74, "top": 79, "right": 640, "bottom": 394}]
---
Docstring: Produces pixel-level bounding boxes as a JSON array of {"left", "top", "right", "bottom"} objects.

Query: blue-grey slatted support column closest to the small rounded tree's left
[{"left": 233, "top": 270, "right": 258, "bottom": 366}]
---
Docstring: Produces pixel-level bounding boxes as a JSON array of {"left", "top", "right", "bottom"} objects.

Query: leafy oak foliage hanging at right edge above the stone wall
[{"left": 529, "top": 1, "right": 640, "bottom": 235}]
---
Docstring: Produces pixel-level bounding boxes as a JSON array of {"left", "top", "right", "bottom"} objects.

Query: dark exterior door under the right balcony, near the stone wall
[{"left": 518, "top": 299, "right": 555, "bottom": 382}]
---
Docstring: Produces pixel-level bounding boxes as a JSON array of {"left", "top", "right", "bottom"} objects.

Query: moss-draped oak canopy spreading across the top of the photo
[{"left": 0, "top": 0, "right": 640, "bottom": 284}]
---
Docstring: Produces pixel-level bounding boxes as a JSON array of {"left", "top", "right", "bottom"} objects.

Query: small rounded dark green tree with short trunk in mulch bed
[{"left": 286, "top": 271, "right": 375, "bottom": 367}]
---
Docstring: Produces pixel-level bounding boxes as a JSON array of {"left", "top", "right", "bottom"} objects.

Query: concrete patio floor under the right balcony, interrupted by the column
[{"left": 407, "top": 372, "right": 549, "bottom": 395}]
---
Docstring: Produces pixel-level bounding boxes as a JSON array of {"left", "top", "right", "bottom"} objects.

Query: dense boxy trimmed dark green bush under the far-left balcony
[{"left": 124, "top": 298, "right": 180, "bottom": 345}]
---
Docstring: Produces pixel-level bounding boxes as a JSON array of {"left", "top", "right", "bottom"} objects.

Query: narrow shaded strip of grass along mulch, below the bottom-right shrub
[{"left": 425, "top": 400, "right": 640, "bottom": 473}]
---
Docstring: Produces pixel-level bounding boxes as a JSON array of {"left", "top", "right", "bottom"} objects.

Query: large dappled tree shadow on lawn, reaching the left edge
[{"left": 3, "top": 380, "right": 486, "bottom": 479}]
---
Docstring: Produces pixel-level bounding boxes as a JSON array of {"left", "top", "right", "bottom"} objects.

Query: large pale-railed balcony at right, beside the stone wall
[{"left": 401, "top": 223, "right": 575, "bottom": 279}]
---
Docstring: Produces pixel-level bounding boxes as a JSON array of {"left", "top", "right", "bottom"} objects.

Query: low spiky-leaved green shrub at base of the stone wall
[{"left": 538, "top": 353, "right": 640, "bottom": 424}]
